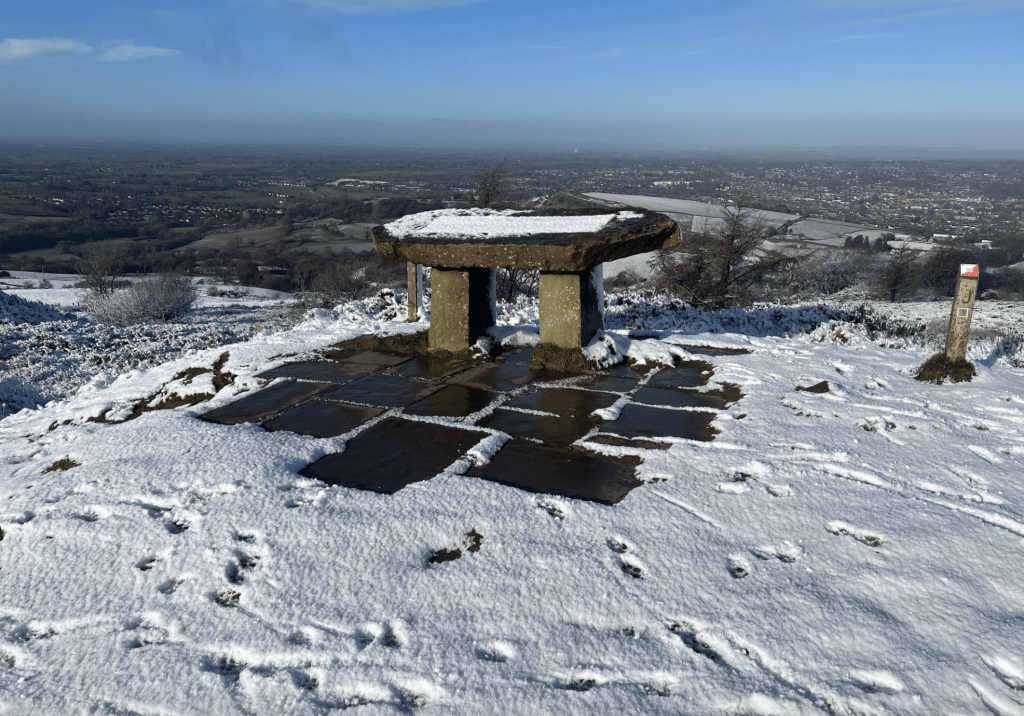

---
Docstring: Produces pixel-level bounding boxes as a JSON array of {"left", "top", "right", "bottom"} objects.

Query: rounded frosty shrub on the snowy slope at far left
[{"left": 84, "top": 276, "right": 197, "bottom": 326}]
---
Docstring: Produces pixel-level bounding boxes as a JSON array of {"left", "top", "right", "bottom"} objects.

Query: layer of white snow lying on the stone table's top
[{"left": 386, "top": 209, "right": 642, "bottom": 240}]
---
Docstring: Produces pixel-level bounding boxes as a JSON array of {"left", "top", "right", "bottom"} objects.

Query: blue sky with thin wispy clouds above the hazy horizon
[{"left": 0, "top": 0, "right": 1024, "bottom": 152}]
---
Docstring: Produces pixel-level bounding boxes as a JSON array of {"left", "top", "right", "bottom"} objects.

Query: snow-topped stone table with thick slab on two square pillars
[{"left": 373, "top": 208, "right": 679, "bottom": 370}]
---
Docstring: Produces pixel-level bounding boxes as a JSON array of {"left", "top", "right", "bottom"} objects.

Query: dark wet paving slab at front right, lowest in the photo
[{"left": 466, "top": 439, "right": 642, "bottom": 505}]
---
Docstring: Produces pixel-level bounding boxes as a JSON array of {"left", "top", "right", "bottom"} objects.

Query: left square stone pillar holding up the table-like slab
[{"left": 429, "top": 266, "right": 495, "bottom": 353}]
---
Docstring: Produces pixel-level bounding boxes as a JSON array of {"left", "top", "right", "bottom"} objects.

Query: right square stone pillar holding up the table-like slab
[{"left": 541, "top": 268, "right": 604, "bottom": 349}]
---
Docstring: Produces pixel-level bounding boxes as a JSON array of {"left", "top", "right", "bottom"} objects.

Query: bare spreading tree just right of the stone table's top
[{"left": 654, "top": 197, "right": 795, "bottom": 308}]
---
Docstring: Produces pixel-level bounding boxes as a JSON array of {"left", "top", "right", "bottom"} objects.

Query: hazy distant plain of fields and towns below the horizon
[{"left": 0, "top": 144, "right": 1024, "bottom": 276}]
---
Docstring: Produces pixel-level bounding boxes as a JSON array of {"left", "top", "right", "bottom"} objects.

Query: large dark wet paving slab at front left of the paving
[{"left": 299, "top": 418, "right": 487, "bottom": 495}]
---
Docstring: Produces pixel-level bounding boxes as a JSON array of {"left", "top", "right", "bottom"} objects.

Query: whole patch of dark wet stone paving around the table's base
[{"left": 202, "top": 346, "right": 745, "bottom": 504}]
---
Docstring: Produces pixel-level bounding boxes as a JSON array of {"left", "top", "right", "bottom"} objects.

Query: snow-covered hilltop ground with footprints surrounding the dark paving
[{"left": 0, "top": 288, "right": 1024, "bottom": 715}]
